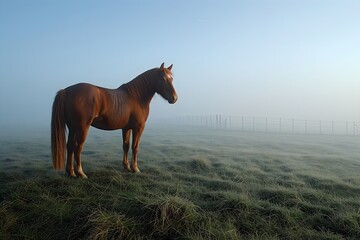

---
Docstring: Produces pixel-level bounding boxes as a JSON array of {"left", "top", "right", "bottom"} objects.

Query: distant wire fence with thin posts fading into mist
[{"left": 167, "top": 114, "right": 360, "bottom": 135}]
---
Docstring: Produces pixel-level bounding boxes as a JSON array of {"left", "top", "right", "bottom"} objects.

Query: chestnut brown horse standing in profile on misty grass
[{"left": 51, "top": 63, "right": 178, "bottom": 178}]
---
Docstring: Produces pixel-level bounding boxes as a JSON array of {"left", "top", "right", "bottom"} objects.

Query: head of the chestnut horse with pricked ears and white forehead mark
[{"left": 156, "top": 63, "right": 178, "bottom": 104}]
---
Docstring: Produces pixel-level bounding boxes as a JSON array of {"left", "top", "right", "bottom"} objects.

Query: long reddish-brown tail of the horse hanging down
[{"left": 51, "top": 90, "right": 66, "bottom": 170}]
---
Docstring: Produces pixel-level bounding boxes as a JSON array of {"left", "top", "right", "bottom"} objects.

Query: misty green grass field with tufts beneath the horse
[{"left": 0, "top": 127, "right": 360, "bottom": 239}]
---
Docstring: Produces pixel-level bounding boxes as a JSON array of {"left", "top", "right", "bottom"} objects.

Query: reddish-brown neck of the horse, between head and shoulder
[{"left": 120, "top": 70, "right": 156, "bottom": 104}]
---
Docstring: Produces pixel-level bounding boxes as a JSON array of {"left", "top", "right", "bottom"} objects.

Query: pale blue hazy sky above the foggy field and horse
[{"left": 0, "top": 0, "right": 360, "bottom": 125}]
